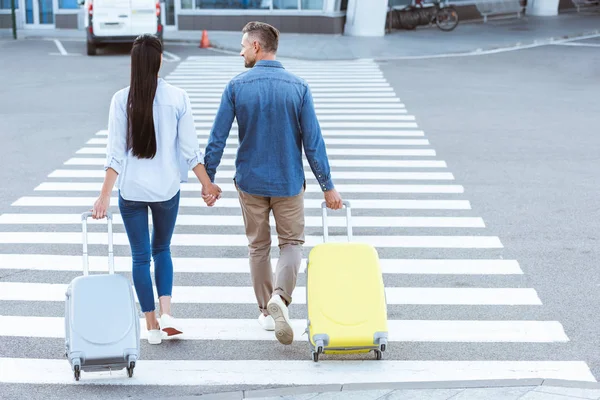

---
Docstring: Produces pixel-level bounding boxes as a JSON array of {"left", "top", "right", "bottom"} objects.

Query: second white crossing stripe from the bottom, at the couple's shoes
[{"left": 0, "top": 316, "right": 569, "bottom": 343}]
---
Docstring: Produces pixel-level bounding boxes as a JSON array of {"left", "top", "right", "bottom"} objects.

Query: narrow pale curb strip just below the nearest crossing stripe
[{"left": 155, "top": 378, "right": 600, "bottom": 400}]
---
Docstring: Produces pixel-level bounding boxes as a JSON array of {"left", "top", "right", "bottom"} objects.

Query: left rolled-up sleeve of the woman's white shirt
[{"left": 104, "top": 93, "right": 127, "bottom": 174}]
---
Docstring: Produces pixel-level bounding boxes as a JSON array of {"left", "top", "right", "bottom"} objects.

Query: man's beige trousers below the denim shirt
[{"left": 238, "top": 182, "right": 305, "bottom": 315}]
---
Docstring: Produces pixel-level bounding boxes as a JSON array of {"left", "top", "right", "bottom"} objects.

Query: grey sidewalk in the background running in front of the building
[{"left": 0, "top": 12, "right": 600, "bottom": 60}]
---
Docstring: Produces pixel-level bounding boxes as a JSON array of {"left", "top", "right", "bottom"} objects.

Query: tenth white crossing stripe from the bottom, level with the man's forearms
[{"left": 65, "top": 157, "right": 447, "bottom": 168}]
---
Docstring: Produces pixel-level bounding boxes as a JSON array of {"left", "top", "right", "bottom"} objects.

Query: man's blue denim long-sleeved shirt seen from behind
[{"left": 204, "top": 60, "right": 334, "bottom": 197}]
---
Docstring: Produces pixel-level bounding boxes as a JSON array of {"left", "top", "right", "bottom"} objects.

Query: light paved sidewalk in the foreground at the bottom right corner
[{"left": 157, "top": 379, "right": 600, "bottom": 400}]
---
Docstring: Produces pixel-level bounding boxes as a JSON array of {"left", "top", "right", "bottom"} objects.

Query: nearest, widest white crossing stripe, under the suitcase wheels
[{"left": 0, "top": 358, "right": 596, "bottom": 386}]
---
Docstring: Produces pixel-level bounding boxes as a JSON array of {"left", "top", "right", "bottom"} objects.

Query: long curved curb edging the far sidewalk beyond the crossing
[{"left": 204, "top": 29, "right": 600, "bottom": 61}]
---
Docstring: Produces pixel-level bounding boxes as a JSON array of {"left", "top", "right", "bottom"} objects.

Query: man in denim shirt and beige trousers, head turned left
[{"left": 204, "top": 22, "right": 342, "bottom": 344}]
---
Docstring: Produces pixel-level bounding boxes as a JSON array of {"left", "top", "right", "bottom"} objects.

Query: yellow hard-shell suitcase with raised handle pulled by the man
[{"left": 306, "top": 201, "right": 388, "bottom": 362}]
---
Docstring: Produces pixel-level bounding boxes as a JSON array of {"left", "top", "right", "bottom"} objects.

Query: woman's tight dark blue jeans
[{"left": 119, "top": 192, "right": 180, "bottom": 313}]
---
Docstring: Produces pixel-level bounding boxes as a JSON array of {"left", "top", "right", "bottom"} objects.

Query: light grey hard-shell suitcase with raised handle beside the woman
[{"left": 65, "top": 212, "right": 140, "bottom": 381}]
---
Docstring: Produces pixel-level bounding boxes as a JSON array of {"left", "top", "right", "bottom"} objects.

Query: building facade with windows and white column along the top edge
[{"left": 0, "top": 0, "right": 573, "bottom": 36}]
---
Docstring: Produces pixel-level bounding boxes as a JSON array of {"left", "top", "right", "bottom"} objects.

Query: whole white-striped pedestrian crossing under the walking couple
[{"left": 0, "top": 56, "right": 596, "bottom": 388}]
